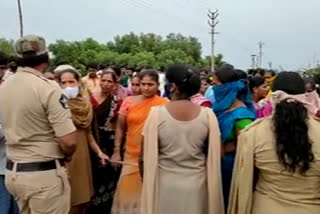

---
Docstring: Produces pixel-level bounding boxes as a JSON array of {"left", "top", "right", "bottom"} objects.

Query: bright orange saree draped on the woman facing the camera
[{"left": 111, "top": 96, "right": 169, "bottom": 214}]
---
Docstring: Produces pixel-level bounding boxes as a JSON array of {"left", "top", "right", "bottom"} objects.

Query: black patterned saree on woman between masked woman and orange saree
[{"left": 87, "top": 95, "right": 121, "bottom": 214}]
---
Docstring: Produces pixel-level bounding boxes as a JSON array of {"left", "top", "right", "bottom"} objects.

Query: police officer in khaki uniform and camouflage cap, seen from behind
[{"left": 0, "top": 35, "right": 77, "bottom": 214}]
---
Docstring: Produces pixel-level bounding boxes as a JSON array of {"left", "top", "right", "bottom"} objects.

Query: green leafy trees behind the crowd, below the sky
[{"left": 0, "top": 33, "right": 223, "bottom": 74}]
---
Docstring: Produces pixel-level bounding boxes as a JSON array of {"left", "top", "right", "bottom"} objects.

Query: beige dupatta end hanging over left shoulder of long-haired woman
[{"left": 228, "top": 120, "right": 261, "bottom": 214}]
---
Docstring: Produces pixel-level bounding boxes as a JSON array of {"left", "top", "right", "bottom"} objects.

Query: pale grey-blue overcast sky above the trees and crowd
[{"left": 0, "top": 0, "right": 320, "bottom": 70}]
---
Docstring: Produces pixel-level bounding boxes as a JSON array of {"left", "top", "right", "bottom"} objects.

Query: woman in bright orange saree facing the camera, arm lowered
[{"left": 111, "top": 70, "right": 169, "bottom": 214}]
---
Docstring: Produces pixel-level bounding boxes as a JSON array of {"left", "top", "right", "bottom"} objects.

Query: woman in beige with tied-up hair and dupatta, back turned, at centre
[{"left": 141, "top": 65, "right": 224, "bottom": 214}]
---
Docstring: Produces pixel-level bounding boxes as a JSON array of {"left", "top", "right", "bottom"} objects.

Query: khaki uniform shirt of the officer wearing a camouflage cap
[{"left": 0, "top": 67, "right": 76, "bottom": 161}]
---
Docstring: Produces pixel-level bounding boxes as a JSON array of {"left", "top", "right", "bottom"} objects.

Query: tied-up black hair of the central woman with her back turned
[{"left": 166, "top": 64, "right": 201, "bottom": 99}]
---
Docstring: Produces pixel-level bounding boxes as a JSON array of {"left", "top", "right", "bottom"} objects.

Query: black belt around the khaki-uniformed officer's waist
[{"left": 7, "top": 159, "right": 64, "bottom": 172}]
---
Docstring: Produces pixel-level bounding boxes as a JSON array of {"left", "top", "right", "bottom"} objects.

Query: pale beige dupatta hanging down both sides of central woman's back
[{"left": 141, "top": 107, "right": 224, "bottom": 214}]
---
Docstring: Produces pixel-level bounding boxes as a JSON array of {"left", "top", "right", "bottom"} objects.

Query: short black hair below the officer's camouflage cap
[{"left": 17, "top": 52, "right": 49, "bottom": 67}]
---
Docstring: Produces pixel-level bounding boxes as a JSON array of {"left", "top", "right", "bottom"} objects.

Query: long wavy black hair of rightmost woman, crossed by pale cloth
[{"left": 272, "top": 72, "right": 314, "bottom": 174}]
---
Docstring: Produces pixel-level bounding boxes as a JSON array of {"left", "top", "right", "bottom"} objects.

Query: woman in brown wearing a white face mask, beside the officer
[{"left": 58, "top": 69, "right": 109, "bottom": 214}]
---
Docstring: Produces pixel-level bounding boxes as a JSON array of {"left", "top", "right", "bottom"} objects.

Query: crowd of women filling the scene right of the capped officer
[{"left": 36, "top": 64, "right": 320, "bottom": 214}]
